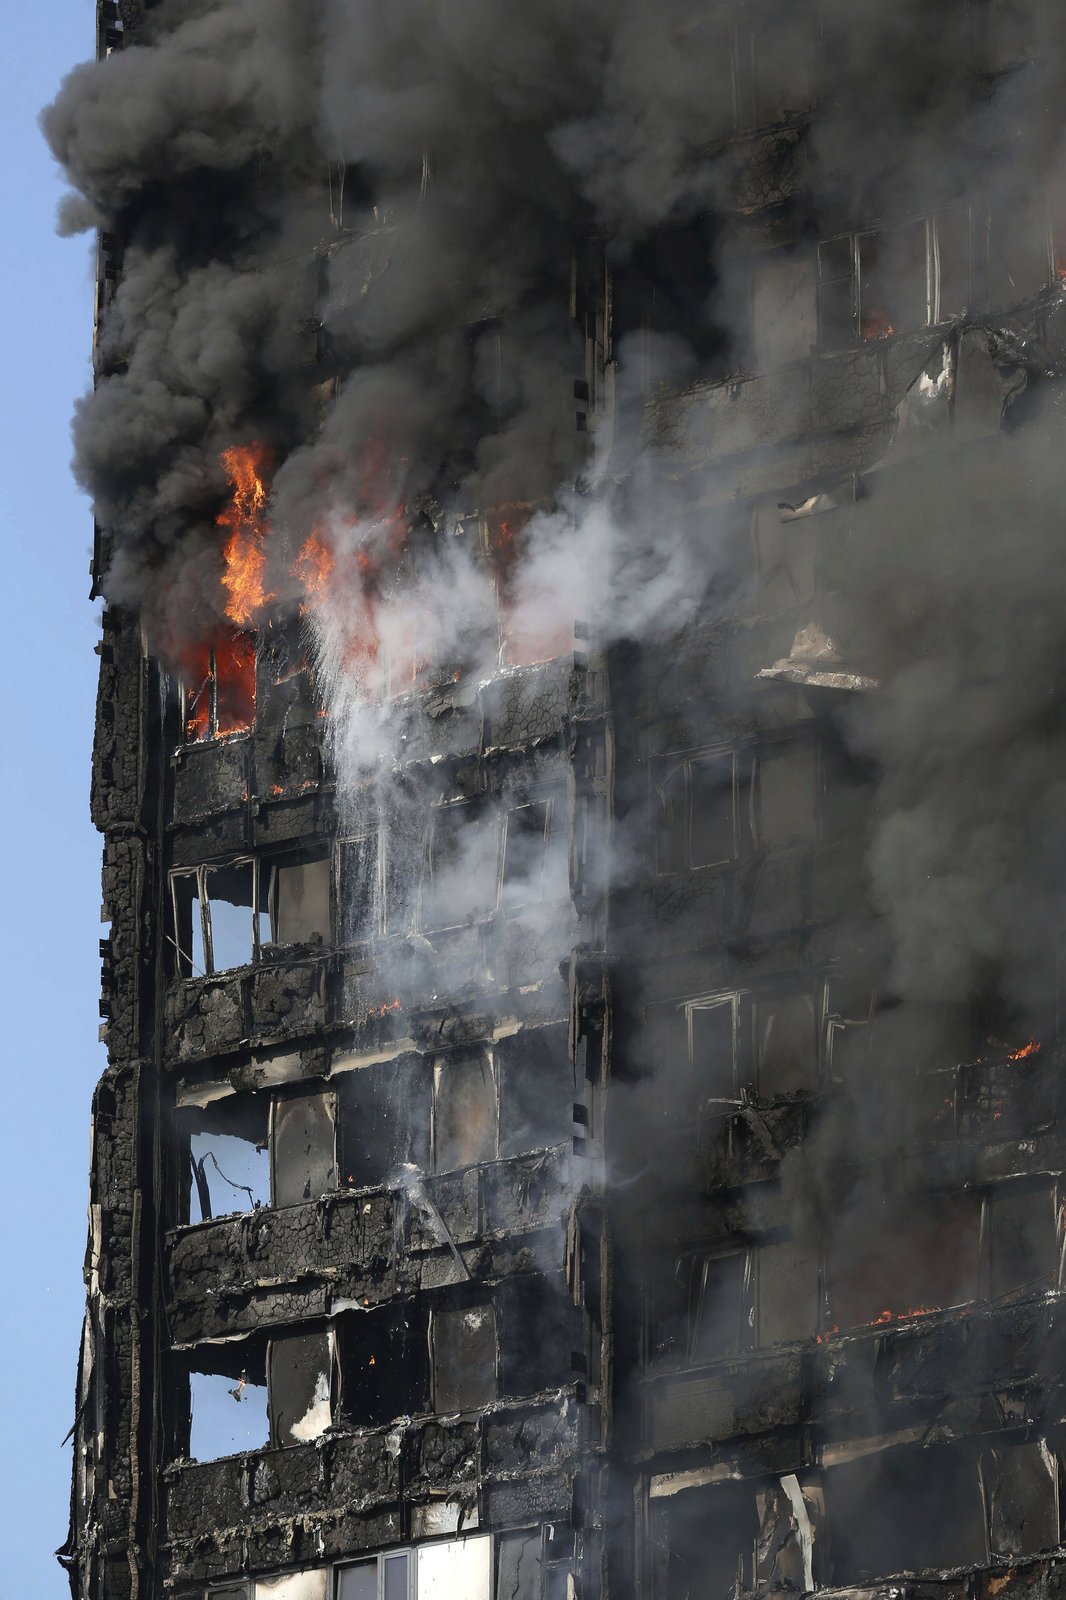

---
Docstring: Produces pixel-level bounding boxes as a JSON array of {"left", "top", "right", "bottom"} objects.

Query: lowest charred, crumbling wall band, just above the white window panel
[{"left": 165, "top": 1390, "right": 583, "bottom": 1584}]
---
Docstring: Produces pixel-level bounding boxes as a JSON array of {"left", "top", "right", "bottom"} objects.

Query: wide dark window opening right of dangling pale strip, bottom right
[{"left": 821, "top": 1445, "right": 988, "bottom": 1587}]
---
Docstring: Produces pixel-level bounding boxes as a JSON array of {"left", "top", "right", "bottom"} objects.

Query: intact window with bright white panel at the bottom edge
[{"left": 334, "top": 1533, "right": 492, "bottom": 1600}]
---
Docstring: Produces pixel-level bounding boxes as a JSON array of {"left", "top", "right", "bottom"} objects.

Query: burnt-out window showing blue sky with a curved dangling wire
[{"left": 178, "top": 1094, "right": 271, "bottom": 1222}]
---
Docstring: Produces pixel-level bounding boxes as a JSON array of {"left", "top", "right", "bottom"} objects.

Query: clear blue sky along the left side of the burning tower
[{"left": 0, "top": 0, "right": 104, "bottom": 1600}]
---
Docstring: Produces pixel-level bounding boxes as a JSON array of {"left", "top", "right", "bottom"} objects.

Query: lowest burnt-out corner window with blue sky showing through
[{"left": 180, "top": 1339, "right": 271, "bottom": 1461}]
